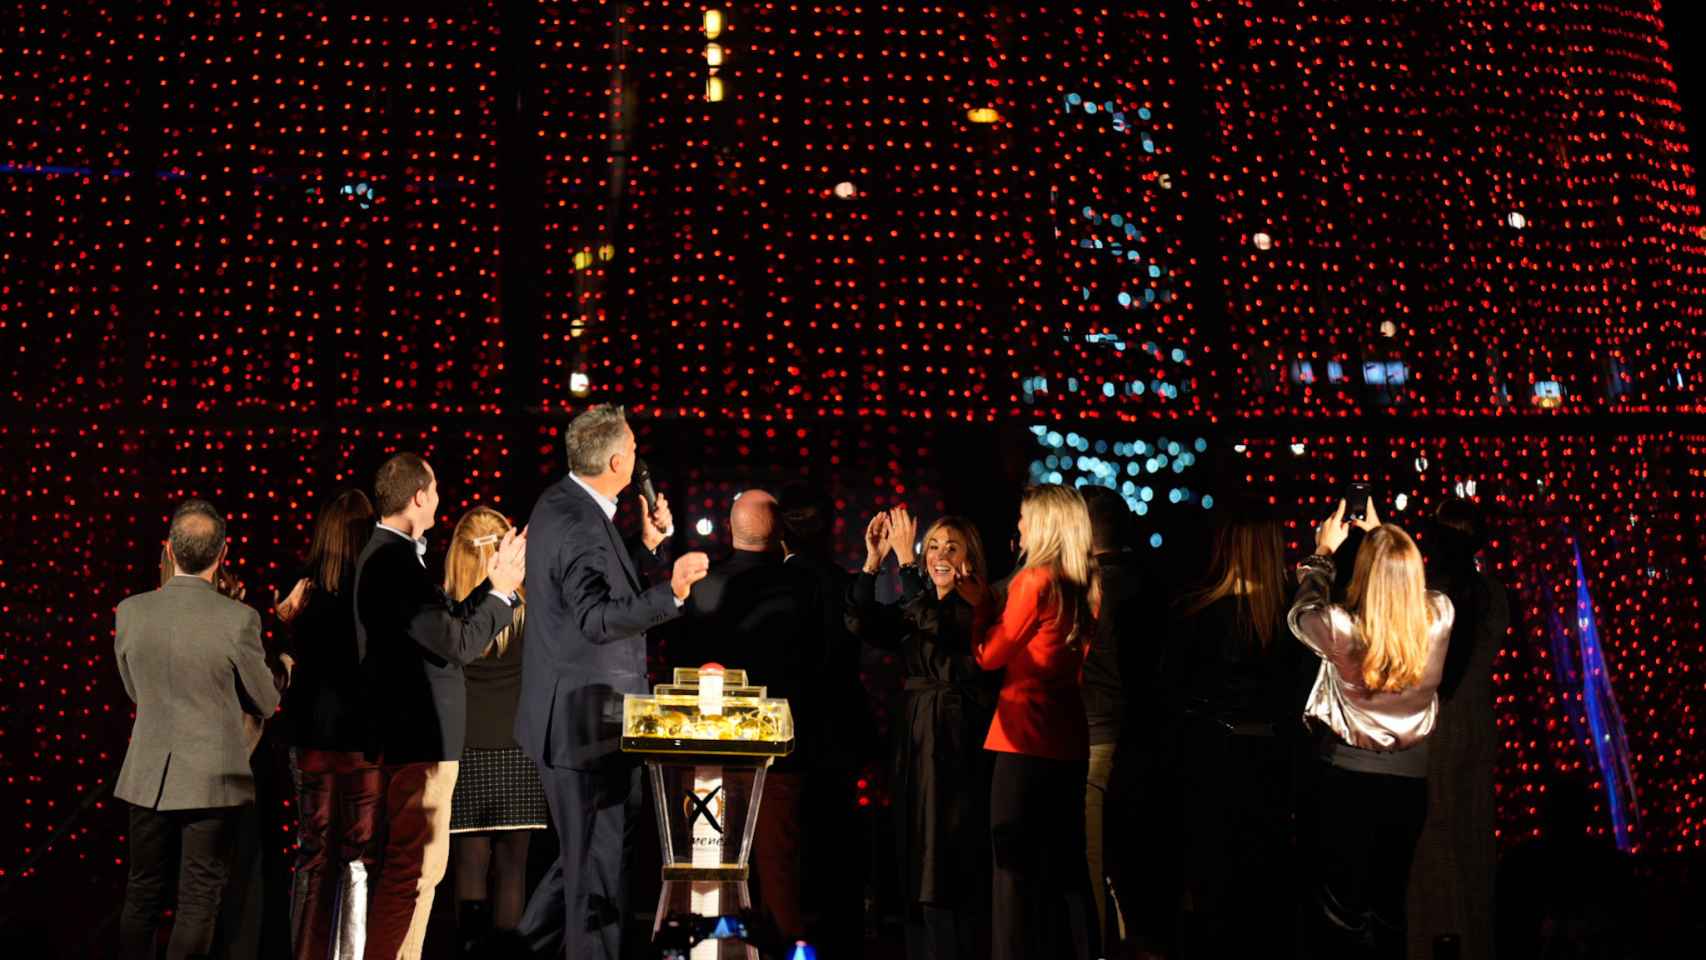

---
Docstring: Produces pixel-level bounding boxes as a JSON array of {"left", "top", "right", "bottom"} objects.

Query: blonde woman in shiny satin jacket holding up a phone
[{"left": 1288, "top": 500, "right": 1454, "bottom": 957}]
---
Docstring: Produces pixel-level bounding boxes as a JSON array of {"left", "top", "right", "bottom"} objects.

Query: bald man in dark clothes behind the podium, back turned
[{"left": 667, "top": 489, "right": 827, "bottom": 943}]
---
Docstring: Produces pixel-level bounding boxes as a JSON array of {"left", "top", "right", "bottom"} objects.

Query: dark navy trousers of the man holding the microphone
[{"left": 519, "top": 760, "right": 641, "bottom": 960}]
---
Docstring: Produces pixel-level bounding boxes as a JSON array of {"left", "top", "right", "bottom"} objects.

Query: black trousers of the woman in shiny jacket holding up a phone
[{"left": 1317, "top": 764, "right": 1428, "bottom": 957}]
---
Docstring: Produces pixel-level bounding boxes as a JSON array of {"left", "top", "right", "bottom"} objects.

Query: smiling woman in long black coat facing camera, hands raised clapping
[{"left": 846, "top": 508, "right": 1000, "bottom": 960}]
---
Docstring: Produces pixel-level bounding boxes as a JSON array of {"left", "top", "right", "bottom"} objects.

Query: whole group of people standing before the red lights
[{"left": 114, "top": 406, "right": 1508, "bottom": 960}]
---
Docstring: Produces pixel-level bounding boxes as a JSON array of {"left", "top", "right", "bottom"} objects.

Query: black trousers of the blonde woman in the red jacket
[{"left": 989, "top": 754, "right": 1100, "bottom": 960}]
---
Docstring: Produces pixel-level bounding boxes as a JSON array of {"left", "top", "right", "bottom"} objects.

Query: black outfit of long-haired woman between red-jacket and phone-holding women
[{"left": 1162, "top": 597, "right": 1303, "bottom": 958}]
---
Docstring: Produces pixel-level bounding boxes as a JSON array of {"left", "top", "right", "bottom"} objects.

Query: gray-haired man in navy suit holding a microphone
[{"left": 515, "top": 404, "right": 710, "bottom": 960}]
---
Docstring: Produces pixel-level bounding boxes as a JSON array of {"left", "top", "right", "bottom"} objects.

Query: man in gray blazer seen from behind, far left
[{"left": 113, "top": 500, "right": 278, "bottom": 960}]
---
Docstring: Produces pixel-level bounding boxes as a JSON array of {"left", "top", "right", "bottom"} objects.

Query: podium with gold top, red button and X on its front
[{"left": 623, "top": 663, "right": 793, "bottom": 960}]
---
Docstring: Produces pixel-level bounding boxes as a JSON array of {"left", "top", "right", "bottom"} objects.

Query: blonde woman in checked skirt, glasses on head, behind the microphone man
[{"left": 444, "top": 506, "right": 549, "bottom": 953}]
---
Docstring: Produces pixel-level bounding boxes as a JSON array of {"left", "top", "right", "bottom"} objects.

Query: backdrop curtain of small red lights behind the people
[{"left": 0, "top": 0, "right": 1706, "bottom": 948}]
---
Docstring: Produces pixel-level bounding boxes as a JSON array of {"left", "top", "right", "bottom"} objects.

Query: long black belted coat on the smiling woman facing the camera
[{"left": 846, "top": 568, "right": 1000, "bottom": 909}]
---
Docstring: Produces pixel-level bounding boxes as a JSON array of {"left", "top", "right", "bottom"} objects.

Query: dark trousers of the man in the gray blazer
[{"left": 119, "top": 805, "right": 242, "bottom": 960}]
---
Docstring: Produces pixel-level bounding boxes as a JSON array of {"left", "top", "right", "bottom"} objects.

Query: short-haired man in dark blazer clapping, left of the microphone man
[{"left": 355, "top": 454, "right": 527, "bottom": 960}]
